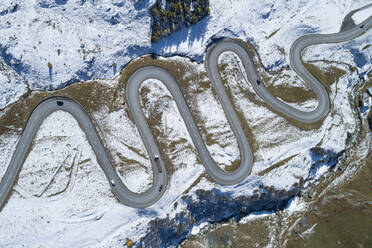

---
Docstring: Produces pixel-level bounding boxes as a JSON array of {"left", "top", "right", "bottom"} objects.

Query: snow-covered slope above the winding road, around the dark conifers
[{"left": 0, "top": 0, "right": 369, "bottom": 108}]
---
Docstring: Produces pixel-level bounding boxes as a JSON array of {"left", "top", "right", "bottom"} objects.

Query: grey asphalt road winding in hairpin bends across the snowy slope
[{"left": 0, "top": 9, "right": 372, "bottom": 209}]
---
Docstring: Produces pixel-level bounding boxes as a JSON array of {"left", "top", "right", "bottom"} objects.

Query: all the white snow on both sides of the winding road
[{"left": 0, "top": 0, "right": 372, "bottom": 247}]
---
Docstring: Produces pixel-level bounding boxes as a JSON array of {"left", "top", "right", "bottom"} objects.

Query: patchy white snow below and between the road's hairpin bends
[{"left": 0, "top": 44, "right": 370, "bottom": 247}]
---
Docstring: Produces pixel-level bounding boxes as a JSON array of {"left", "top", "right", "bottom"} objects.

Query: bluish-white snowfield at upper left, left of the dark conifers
[{"left": 0, "top": 0, "right": 151, "bottom": 90}]
